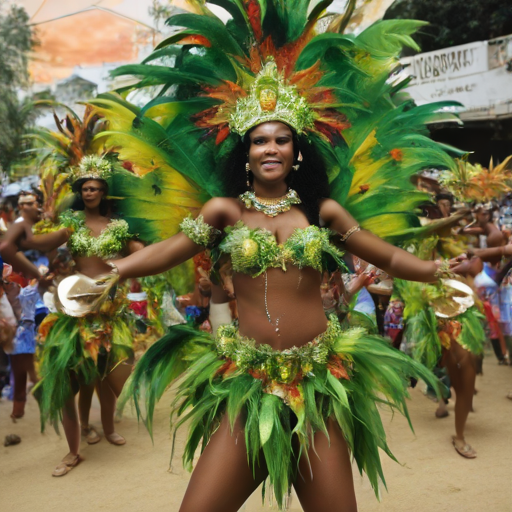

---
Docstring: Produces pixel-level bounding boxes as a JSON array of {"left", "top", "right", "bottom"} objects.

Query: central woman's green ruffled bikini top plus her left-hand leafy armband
[{"left": 181, "top": 216, "right": 344, "bottom": 277}]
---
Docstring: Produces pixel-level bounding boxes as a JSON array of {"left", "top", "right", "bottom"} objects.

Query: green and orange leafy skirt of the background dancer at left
[{"left": 34, "top": 298, "right": 133, "bottom": 431}]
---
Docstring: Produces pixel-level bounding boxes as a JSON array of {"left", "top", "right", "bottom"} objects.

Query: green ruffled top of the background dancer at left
[{"left": 60, "top": 211, "right": 133, "bottom": 259}]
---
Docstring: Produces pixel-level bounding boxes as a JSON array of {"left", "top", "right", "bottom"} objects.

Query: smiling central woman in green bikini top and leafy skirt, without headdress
[{"left": 102, "top": 119, "right": 450, "bottom": 510}]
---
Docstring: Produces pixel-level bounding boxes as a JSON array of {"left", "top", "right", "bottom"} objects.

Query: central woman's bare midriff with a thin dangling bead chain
[{"left": 233, "top": 265, "right": 327, "bottom": 350}]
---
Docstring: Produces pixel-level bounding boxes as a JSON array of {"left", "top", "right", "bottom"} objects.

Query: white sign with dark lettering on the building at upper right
[{"left": 402, "top": 36, "right": 512, "bottom": 120}]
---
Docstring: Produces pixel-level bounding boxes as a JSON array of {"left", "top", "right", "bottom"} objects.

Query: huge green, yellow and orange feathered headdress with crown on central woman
[{"left": 91, "top": 0, "right": 459, "bottom": 246}]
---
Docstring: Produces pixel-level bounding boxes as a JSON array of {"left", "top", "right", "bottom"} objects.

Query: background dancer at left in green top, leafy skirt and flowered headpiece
[{"left": 1, "top": 155, "right": 143, "bottom": 476}]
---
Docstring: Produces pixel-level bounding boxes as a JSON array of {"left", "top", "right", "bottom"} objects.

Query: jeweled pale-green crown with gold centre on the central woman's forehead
[{"left": 229, "top": 59, "right": 314, "bottom": 137}]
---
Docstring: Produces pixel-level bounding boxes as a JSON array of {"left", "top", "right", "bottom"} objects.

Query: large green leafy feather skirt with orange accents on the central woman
[{"left": 120, "top": 316, "right": 437, "bottom": 509}]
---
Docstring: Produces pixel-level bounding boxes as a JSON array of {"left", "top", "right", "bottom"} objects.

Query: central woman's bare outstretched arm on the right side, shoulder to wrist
[{"left": 320, "top": 199, "right": 439, "bottom": 283}]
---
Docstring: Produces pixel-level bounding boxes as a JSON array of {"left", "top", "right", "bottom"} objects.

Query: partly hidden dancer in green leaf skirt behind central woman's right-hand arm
[{"left": 395, "top": 198, "right": 485, "bottom": 459}]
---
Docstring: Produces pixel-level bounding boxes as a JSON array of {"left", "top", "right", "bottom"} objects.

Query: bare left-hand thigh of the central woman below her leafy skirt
[{"left": 180, "top": 416, "right": 268, "bottom": 512}]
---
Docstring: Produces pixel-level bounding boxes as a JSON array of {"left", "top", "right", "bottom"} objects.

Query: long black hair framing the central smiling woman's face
[{"left": 225, "top": 123, "right": 330, "bottom": 226}]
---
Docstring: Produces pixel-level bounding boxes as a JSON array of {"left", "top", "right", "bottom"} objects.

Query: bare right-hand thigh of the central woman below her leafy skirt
[{"left": 293, "top": 419, "right": 357, "bottom": 512}]
